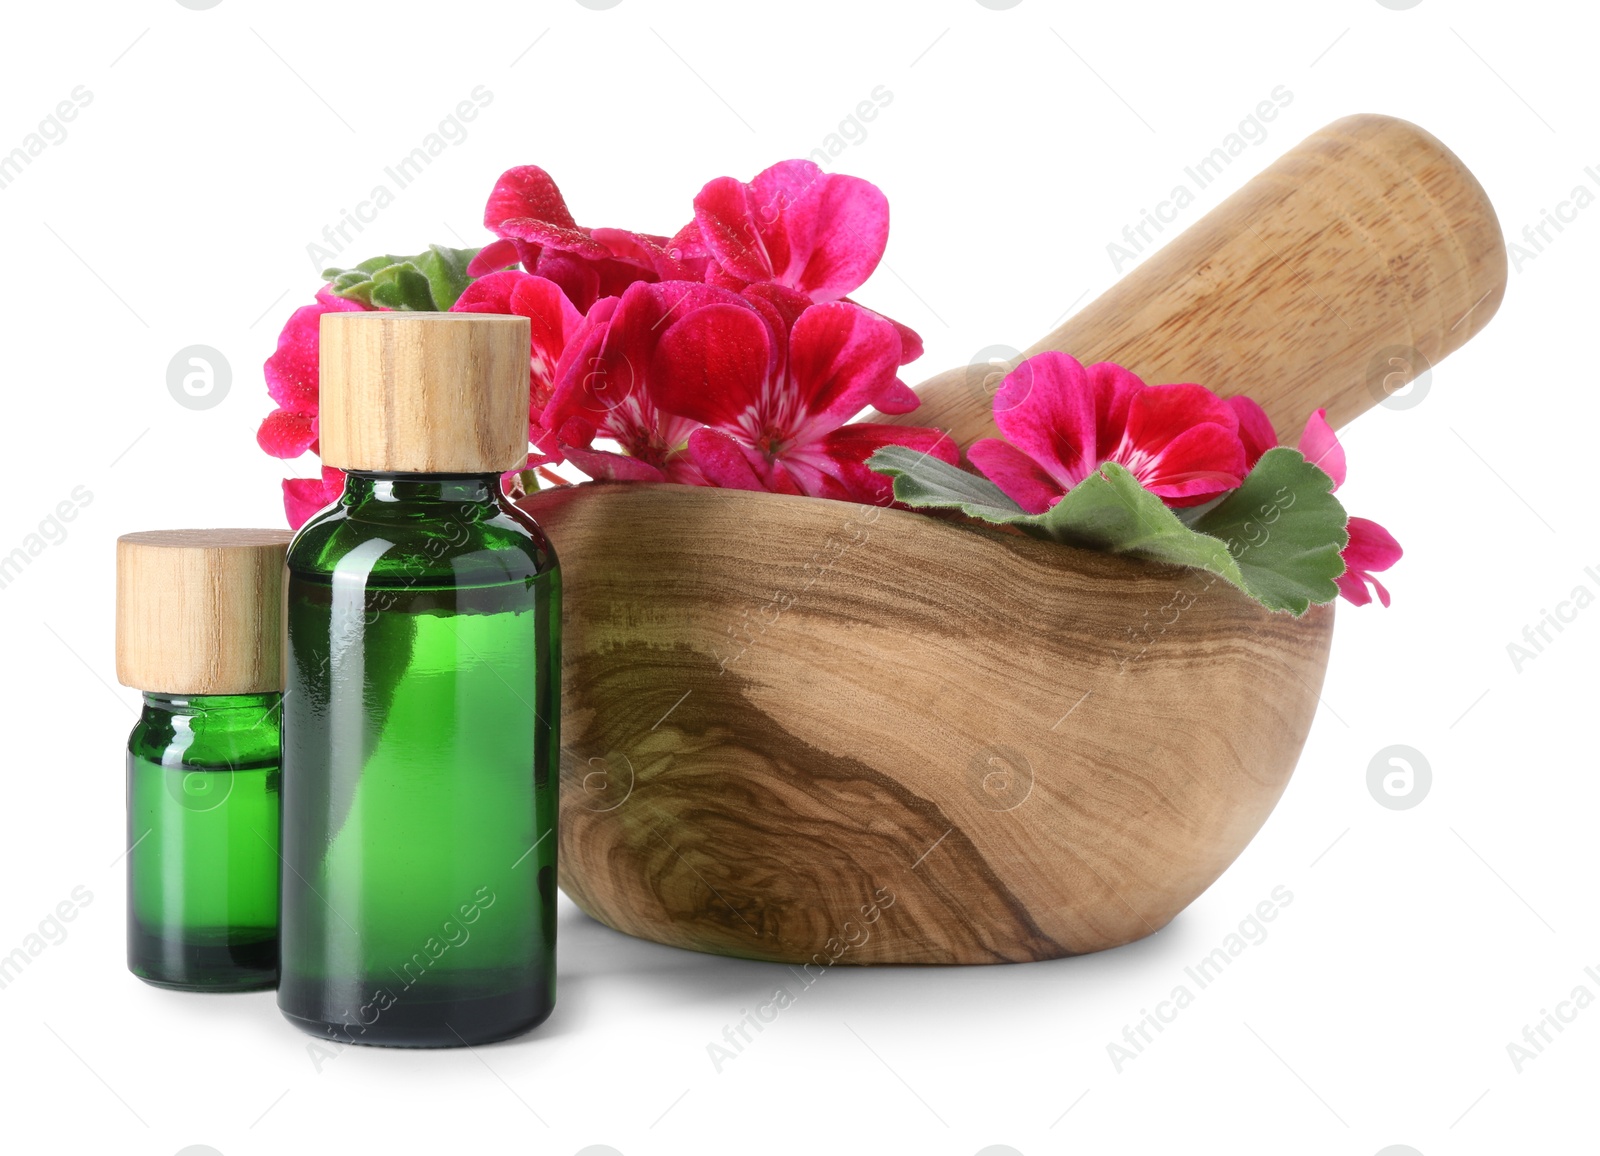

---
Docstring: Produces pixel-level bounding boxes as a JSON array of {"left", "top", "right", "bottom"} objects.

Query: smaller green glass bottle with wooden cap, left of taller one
[{"left": 117, "top": 530, "right": 290, "bottom": 991}]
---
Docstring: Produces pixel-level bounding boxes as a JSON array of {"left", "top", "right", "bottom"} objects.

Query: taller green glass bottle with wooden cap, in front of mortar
[{"left": 278, "top": 312, "right": 560, "bottom": 1047}]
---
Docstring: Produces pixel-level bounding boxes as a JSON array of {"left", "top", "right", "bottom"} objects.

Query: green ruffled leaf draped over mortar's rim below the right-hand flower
[{"left": 867, "top": 445, "right": 1349, "bottom": 615}]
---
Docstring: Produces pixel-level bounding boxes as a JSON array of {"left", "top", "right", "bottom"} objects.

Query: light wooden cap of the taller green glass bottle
[{"left": 318, "top": 312, "right": 528, "bottom": 474}]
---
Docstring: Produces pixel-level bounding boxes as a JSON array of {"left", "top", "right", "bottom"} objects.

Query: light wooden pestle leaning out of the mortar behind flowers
[{"left": 891, "top": 114, "right": 1506, "bottom": 448}]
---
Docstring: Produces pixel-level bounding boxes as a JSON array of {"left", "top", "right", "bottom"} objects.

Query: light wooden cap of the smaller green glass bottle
[{"left": 117, "top": 530, "right": 293, "bottom": 695}]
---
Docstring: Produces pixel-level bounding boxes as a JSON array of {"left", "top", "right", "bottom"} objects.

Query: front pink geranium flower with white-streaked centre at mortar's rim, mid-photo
[{"left": 651, "top": 285, "right": 957, "bottom": 504}]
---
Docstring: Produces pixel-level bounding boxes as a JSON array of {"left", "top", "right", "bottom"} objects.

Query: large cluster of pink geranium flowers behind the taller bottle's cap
[{"left": 258, "top": 160, "right": 957, "bottom": 527}]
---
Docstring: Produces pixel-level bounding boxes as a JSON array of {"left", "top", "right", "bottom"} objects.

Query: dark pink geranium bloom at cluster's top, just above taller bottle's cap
[{"left": 467, "top": 165, "right": 704, "bottom": 312}]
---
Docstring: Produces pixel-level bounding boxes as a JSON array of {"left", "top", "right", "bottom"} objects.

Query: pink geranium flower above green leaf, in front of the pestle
[{"left": 968, "top": 352, "right": 1246, "bottom": 514}]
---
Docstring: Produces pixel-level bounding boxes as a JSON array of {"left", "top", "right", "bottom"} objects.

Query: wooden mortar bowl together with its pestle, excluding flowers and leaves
[{"left": 525, "top": 115, "right": 1506, "bottom": 967}]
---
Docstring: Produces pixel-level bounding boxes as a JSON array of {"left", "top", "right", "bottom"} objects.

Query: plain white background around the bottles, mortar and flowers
[{"left": 0, "top": 0, "right": 1600, "bottom": 1156}]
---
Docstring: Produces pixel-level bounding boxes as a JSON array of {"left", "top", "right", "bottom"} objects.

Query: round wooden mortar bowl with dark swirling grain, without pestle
[{"left": 526, "top": 484, "right": 1333, "bottom": 964}]
